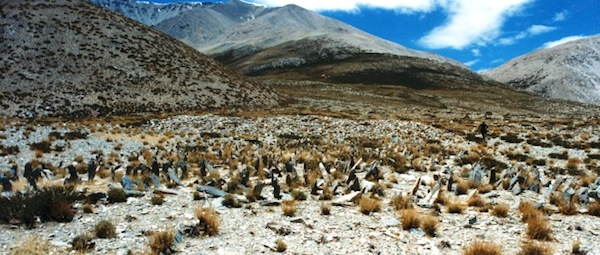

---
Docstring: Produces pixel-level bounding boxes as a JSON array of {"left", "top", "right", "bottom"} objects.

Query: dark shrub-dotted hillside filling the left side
[{"left": 0, "top": 0, "right": 277, "bottom": 117}]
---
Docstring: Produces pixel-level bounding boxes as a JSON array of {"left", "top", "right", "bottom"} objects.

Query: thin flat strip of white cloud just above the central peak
[{"left": 253, "top": 0, "right": 438, "bottom": 12}]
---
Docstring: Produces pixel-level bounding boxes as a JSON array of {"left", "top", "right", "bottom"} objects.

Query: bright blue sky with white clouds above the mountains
[{"left": 158, "top": 0, "right": 600, "bottom": 71}]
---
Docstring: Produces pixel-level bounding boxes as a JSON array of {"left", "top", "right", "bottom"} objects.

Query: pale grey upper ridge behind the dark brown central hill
[{"left": 91, "top": 0, "right": 448, "bottom": 60}]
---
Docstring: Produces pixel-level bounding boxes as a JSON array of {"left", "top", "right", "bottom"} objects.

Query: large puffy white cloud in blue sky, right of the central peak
[{"left": 420, "top": 0, "right": 533, "bottom": 49}]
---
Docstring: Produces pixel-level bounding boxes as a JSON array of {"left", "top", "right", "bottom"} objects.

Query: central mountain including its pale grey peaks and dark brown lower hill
[{"left": 92, "top": 0, "right": 492, "bottom": 88}]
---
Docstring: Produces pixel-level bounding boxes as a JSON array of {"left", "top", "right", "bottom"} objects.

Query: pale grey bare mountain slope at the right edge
[{"left": 485, "top": 36, "right": 600, "bottom": 105}]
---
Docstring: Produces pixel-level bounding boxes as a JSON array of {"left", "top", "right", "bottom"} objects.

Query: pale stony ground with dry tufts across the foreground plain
[{"left": 0, "top": 109, "right": 600, "bottom": 254}]
